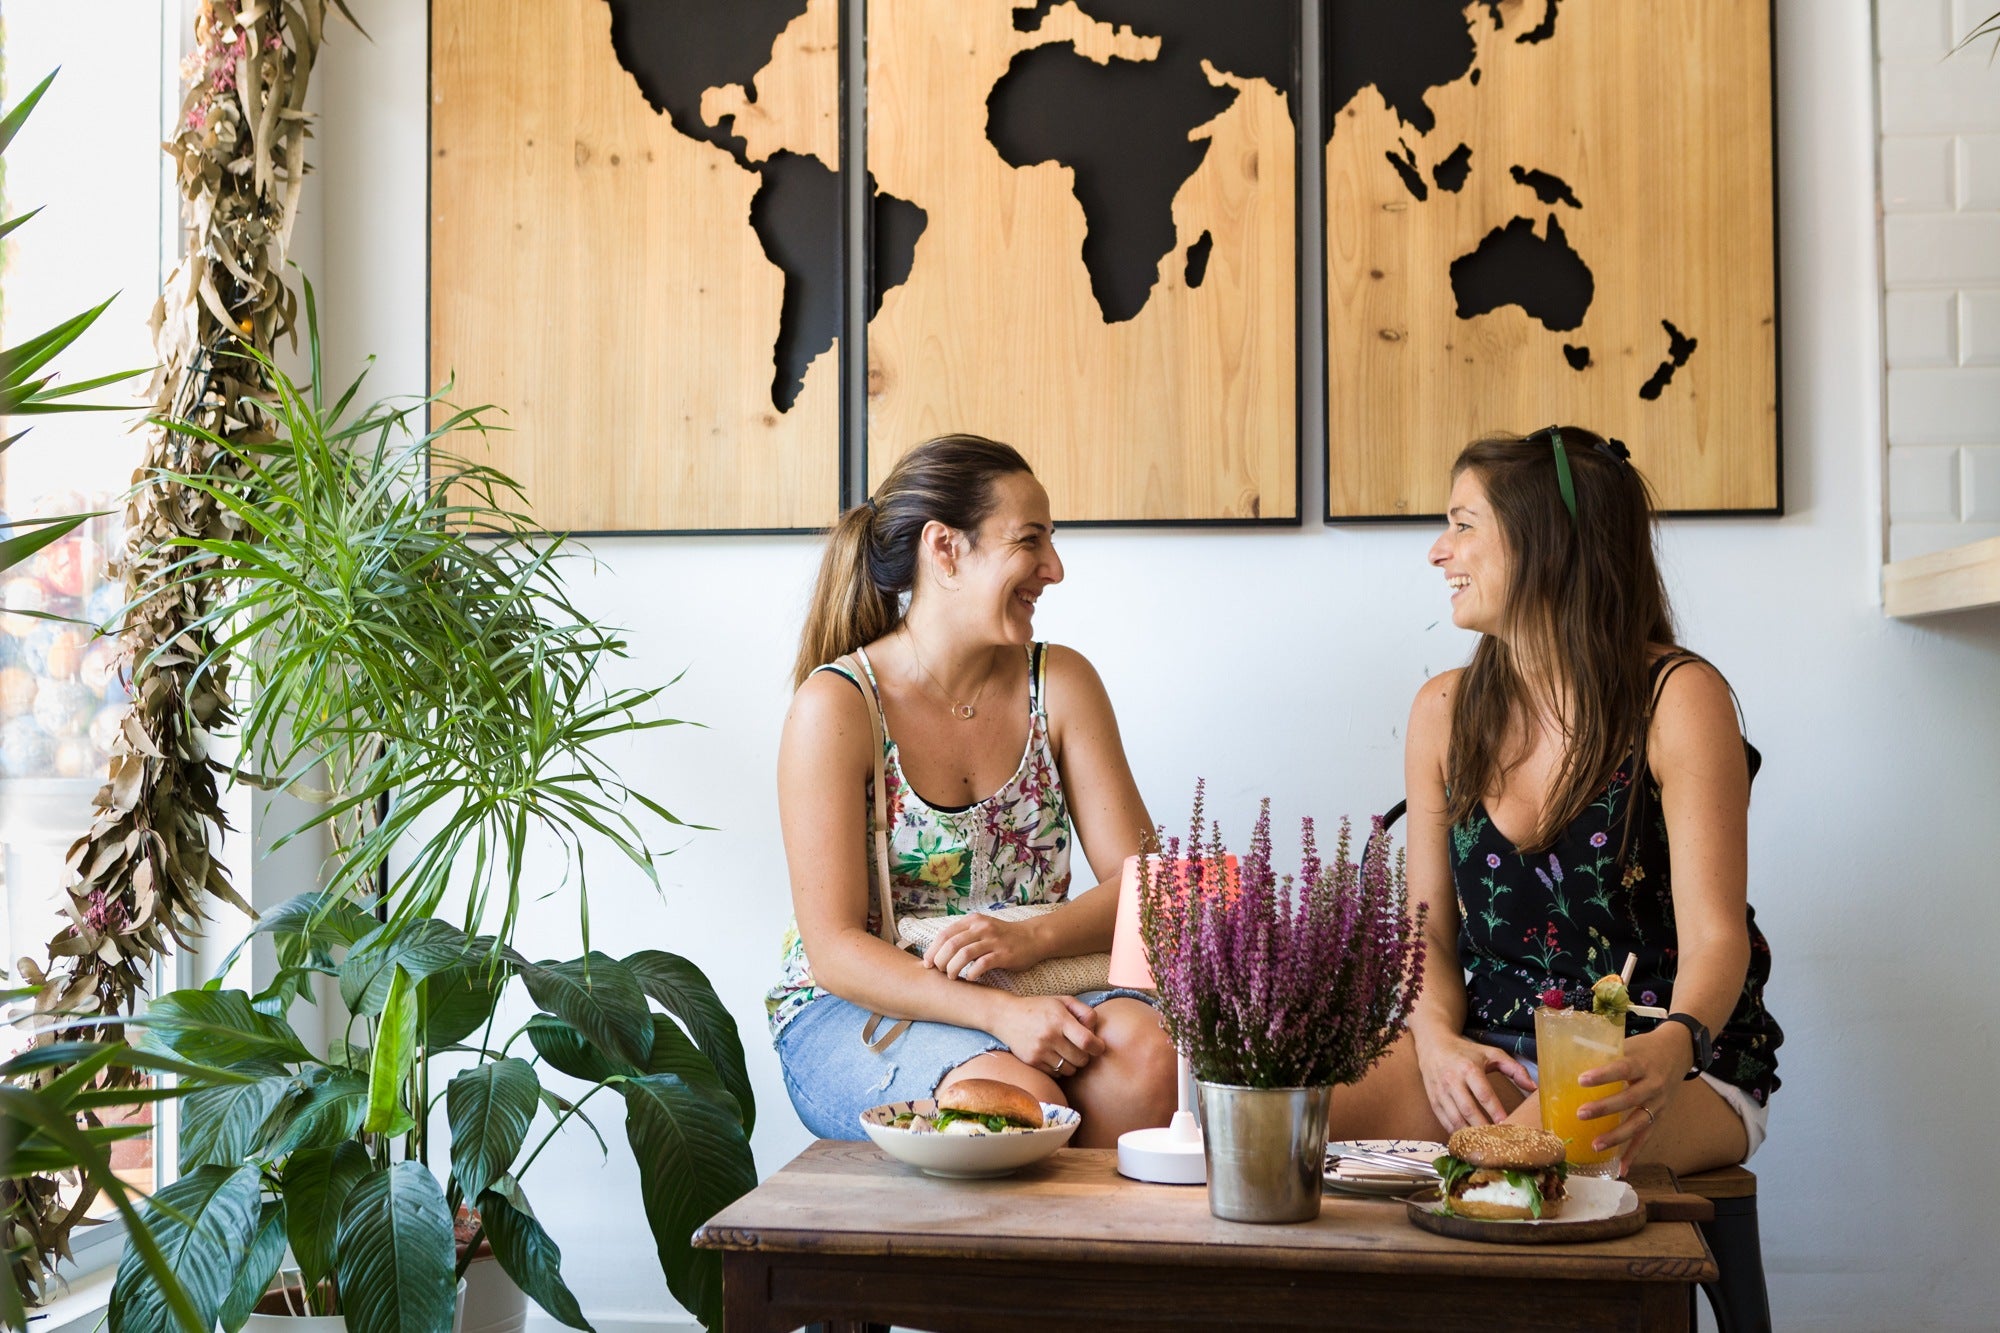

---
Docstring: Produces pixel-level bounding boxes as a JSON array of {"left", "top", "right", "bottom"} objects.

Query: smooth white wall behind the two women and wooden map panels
[{"left": 300, "top": 0, "right": 2000, "bottom": 1329}]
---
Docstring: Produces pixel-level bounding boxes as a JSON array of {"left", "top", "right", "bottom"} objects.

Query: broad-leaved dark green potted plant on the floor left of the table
[{"left": 110, "top": 893, "right": 756, "bottom": 1333}]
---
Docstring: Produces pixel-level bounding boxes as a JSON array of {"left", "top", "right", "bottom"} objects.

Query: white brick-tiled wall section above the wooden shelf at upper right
[{"left": 1876, "top": 0, "right": 2000, "bottom": 560}]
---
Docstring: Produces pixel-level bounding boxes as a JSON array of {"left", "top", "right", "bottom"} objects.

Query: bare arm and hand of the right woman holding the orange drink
[{"left": 1578, "top": 662, "right": 1750, "bottom": 1149}]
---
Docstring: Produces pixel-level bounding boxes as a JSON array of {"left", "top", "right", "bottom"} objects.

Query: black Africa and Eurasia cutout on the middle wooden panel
[{"left": 986, "top": 0, "right": 1292, "bottom": 324}]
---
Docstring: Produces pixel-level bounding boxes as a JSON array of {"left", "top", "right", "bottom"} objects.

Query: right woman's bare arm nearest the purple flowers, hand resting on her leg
[{"left": 1404, "top": 671, "right": 1534, "bottom": 1131}]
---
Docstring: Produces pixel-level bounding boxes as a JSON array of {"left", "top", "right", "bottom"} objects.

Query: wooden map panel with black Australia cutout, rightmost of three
[{"left": 1322, "top": 0, "right": 1780, "bottom": 518}]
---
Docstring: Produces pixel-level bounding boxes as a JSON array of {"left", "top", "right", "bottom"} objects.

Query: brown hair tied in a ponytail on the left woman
[{"left": 792, "top": 434, "right": 1034, "bottom": 689}]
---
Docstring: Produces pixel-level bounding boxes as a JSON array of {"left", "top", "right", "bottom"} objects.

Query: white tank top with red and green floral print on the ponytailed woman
[{"left": 764, "top": 642, "right": 1070, "bottom": 1039}]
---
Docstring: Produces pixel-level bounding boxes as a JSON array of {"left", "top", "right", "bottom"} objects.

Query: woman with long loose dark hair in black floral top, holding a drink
[{"left": 1332, "top": 426, "right": 1784, "bottom": 1171}]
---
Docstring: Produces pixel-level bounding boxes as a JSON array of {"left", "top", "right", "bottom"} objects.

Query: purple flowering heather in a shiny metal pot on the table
[{"left": 1140, "top": 785, "right": 1426, "bottom": 1223}]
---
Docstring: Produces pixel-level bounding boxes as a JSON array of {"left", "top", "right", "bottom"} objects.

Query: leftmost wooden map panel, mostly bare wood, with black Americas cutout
[{"left": 430, "top": 0, "right": 840, "bottom": 532}]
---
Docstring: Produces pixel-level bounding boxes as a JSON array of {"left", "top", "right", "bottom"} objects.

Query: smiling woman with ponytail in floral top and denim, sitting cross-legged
[{"left": 768, "top": 434, "right": 1176, "bottom": 1147}]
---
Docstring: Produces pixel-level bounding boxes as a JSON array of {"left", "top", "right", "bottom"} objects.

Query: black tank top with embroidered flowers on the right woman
[{"left": 1452, "top": 656, "right": 1784, "bottom": 1107}]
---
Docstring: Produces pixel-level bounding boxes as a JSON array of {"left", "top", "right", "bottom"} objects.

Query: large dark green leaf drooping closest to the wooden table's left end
[{"left": 618, "top": 1075, "right": 756, "bottom": 1329}]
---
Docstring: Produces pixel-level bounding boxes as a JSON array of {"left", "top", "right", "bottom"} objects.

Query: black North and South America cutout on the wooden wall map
[{"left": 606, "top": 0, "right": 924, "bottom": 412}]
